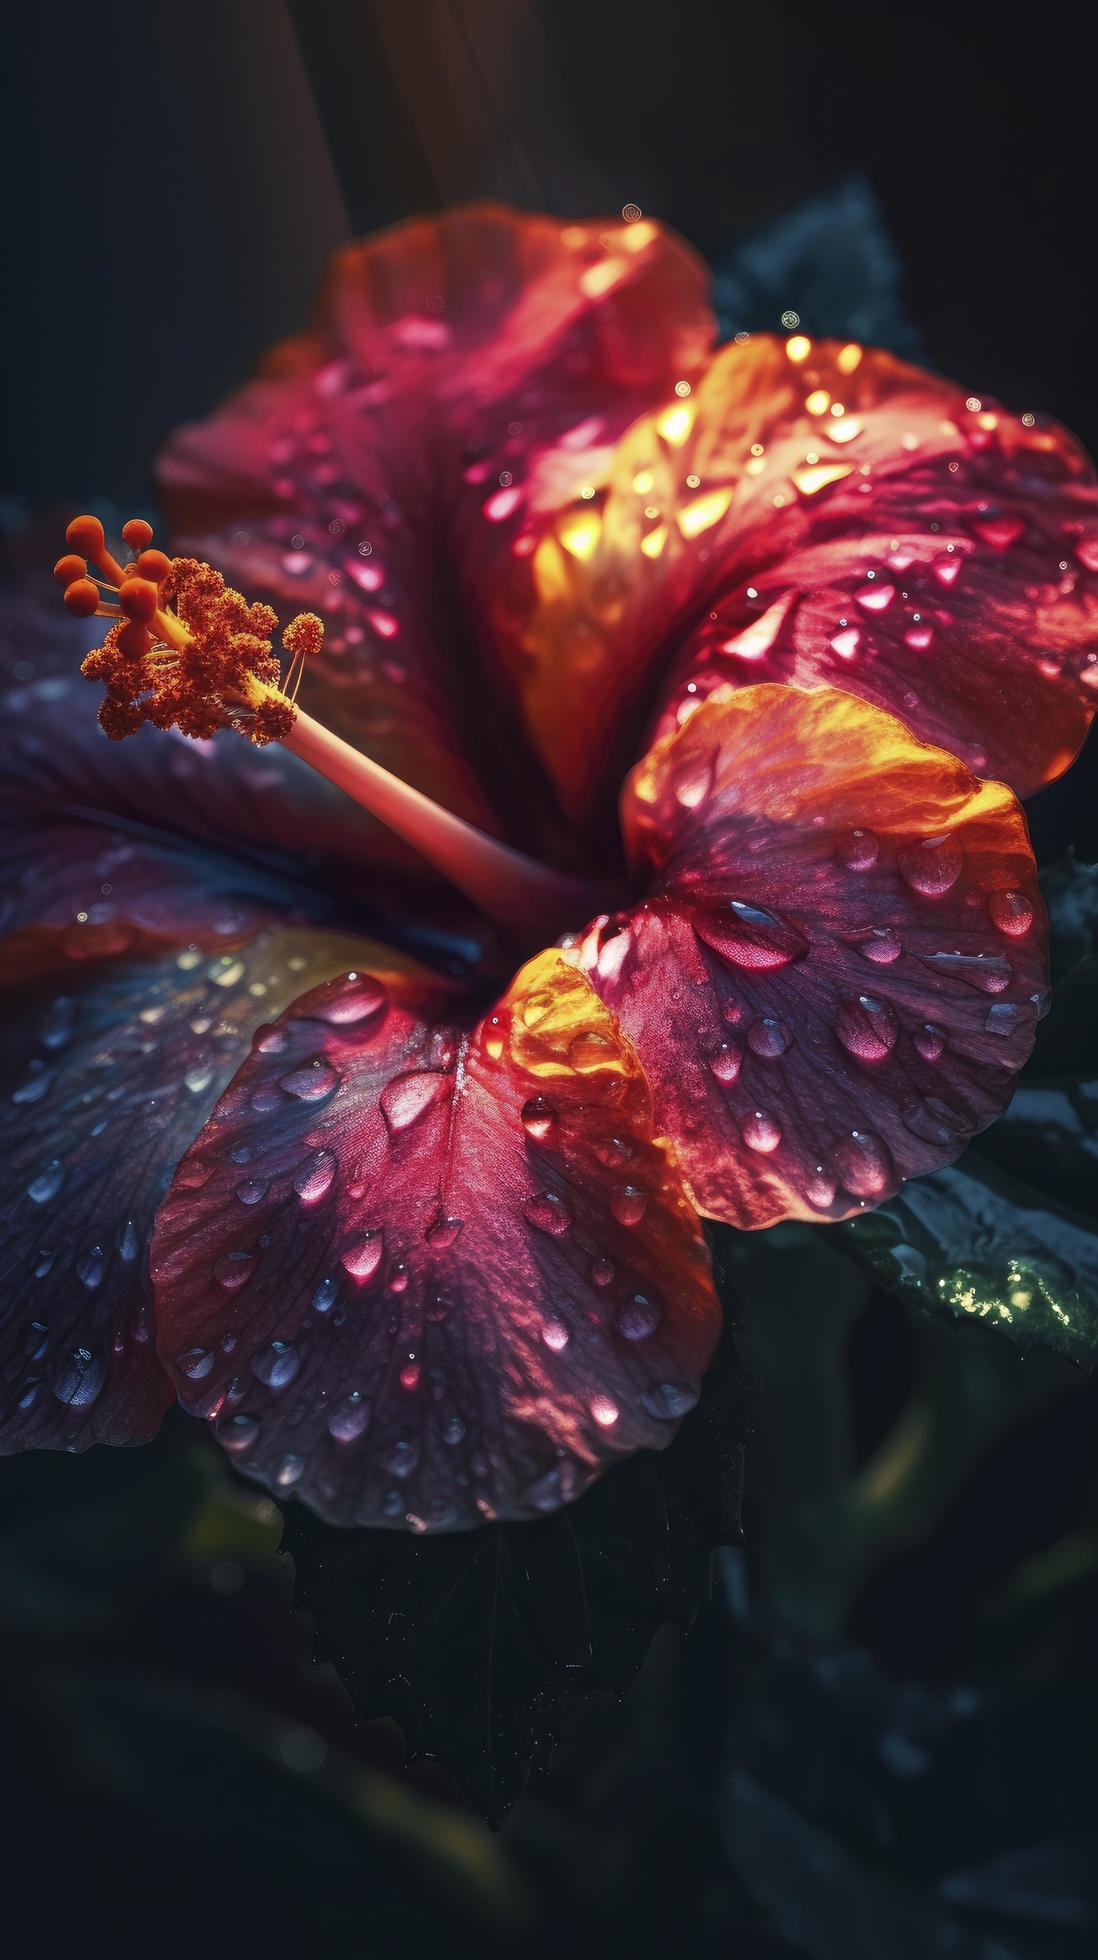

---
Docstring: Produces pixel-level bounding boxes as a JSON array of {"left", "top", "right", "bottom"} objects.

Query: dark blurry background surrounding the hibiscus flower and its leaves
[{"left": 0, "top": 0, "right": 1098, "bottom": 1960}]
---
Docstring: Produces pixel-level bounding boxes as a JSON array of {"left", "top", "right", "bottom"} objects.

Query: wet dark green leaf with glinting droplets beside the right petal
[{"left": 841, "top": 858, "right": 1098, "bottom": 1366}]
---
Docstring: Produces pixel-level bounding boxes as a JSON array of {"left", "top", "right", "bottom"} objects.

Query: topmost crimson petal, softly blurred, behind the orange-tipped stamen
[{"left": 163, "top": 206, "right": 712, "bottom": 858}]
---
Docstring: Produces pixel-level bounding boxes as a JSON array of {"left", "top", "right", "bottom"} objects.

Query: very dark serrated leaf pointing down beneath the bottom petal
[{"left": 284, "top": 1317, "right": 741, "bottom": 1825}]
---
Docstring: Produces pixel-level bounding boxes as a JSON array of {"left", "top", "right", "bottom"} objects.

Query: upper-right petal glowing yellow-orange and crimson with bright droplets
[{"left": 524, "top": 335, "right": 1098, "bottom": 806}]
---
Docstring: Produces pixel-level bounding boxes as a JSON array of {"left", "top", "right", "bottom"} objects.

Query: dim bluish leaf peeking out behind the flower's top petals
[{"left": 714, "top": 174, "right": 920, "bottom": 359}]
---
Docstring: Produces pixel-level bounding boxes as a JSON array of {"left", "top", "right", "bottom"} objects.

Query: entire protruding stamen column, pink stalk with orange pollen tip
[{"left": 53, "top": 517, "right": 602, "bottom": 943}]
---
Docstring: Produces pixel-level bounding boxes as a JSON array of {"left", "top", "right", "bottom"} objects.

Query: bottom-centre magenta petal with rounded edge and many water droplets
[{"left": 153, "top": 953, "right": 718, "bottom": 1529}]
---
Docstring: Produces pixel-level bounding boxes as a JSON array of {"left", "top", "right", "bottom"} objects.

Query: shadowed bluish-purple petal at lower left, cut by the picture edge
[{"left": 0, "top": 933, "right": 376, "bottom": 1450}]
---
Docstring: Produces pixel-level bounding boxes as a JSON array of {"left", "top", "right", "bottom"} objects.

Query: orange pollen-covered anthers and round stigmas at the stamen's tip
[{"left": 55, "top": 517, "right": 324, "bottom": 747}]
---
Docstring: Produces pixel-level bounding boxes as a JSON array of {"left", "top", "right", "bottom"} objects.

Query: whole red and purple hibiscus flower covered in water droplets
[{"left": 0, "top": 208, "right": 1098, "bottom": 1529}]
